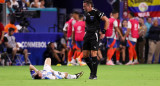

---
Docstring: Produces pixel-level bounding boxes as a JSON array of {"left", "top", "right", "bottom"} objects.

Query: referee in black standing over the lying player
[{"left": 83, "top": 0, "right": 109, "bottom": 79}]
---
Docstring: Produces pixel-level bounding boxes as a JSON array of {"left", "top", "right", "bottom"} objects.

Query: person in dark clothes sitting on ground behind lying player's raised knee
[{"left": 43, "top": 42, "right": 64, "bottom": 66}]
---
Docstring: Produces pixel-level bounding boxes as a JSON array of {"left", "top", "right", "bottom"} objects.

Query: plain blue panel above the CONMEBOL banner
[{"left": 28, "top": 8, "right": 58, "bottom": 32}]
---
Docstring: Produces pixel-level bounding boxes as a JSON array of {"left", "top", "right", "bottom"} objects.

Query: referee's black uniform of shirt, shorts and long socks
[{"left": 83, "top": 9, "right": 105, "bottom": 79}]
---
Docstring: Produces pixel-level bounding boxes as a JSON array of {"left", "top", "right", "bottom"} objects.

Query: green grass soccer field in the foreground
[{"left": 0, "top": 65, "right": 160, "bottom": 86}]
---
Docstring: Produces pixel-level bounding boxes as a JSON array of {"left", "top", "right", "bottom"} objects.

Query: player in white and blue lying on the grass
[{"left": 29, "top": 58, "right": 83, "bottom": 80}]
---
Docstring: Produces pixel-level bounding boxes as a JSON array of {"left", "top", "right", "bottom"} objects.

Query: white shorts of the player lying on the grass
[{"left": 43, "top": 65, "right": 65, "bottom": 79}]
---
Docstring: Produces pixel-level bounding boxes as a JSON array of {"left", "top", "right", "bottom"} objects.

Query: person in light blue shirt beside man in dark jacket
[{"left": 145, "top": 17, "right": 152, "bottom": 63}]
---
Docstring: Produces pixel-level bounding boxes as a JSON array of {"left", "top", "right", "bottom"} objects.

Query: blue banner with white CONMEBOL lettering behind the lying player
[{"left": 15, "top": 33, "right": 63, "bottom": 65}]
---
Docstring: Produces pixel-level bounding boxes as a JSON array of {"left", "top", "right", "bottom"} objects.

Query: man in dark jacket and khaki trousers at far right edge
[{"left": 147, "top": 19, "right": 160, "bottom": 64}]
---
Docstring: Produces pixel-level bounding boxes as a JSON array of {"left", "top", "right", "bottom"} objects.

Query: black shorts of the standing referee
[{"left": 83, "top": 33, "right": 99, "bottom": 51}]
